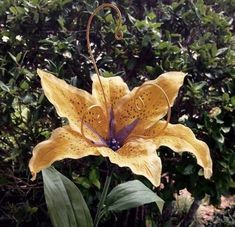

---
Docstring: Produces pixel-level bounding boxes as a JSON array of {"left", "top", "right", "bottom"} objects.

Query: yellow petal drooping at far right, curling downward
[{"left": 145, "top": 121, "right": 212, "bottom": 178}]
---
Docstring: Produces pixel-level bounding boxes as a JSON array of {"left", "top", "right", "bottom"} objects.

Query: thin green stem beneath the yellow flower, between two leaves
[{"left": 94, "top": 171, "right": 112, "bottom": 227}]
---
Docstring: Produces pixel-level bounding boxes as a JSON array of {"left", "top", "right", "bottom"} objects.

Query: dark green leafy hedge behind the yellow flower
[{"left": 0, "top": 0, "right": 235, "bottom": 227}]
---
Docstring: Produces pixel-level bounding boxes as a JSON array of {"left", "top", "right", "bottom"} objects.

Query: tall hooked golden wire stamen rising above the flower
[{"left": 86, "top": 3, "right": 123, "bottom": 116}]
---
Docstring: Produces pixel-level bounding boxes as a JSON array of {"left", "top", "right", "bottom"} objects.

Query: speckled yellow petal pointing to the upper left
[{"left": 37, "top": 69, "right": 108, "bottom": 137}]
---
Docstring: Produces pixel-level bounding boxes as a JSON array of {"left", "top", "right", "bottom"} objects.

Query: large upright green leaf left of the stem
[{"left": 42, "top": 167, "right": 93, "bottom": 227}]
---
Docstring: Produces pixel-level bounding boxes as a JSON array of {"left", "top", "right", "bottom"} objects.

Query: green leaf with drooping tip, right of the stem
[{"left": 105, "top": 180, "right": 164, "bottom": 212}]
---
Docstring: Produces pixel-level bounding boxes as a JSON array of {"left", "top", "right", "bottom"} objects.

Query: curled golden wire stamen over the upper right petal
[{"left": 128, "top": 82, "right": 171, "bottom": 140}]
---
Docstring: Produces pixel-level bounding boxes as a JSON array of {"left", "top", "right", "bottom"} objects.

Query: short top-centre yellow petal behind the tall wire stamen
[{"left": 92, "top": 74, "right": 129, "bottom": 106}]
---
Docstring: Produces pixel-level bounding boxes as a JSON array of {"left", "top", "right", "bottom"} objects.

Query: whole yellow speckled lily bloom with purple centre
[{"left": 29, "top": 70, "right": 212, "bottom": 186}]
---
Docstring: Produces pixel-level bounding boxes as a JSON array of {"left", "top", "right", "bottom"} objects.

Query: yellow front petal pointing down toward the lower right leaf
[{"left": 99, "top": 139, "right": 162, "bottom": 187}]
